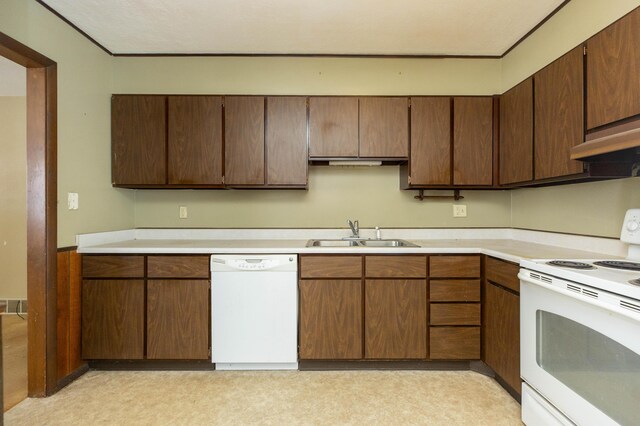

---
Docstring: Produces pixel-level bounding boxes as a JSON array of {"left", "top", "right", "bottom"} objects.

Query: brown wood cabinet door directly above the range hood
[{"left": 587, "top": 9, "right": 640, "bottom": 129}]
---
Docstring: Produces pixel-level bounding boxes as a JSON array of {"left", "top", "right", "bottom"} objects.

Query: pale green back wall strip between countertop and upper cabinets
[{"left": 136, "top": 166, "right": 510, "bottom": 228}]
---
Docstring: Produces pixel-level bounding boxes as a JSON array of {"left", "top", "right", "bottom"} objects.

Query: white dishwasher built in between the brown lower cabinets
[{"left": 211, "top": 254, "right": 298, "bottom": 370}]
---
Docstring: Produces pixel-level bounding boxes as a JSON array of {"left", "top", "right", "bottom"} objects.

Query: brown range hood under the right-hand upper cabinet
[{"left": 571, "top": 118, "right": 640, "bottom": 162}]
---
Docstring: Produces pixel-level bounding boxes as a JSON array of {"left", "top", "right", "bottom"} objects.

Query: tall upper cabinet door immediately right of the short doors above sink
[{"left": 410, "top": 97, "right": 451, "bottom": 185}]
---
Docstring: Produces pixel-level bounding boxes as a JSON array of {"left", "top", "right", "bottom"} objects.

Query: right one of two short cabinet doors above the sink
[{"left": 359, "top": 97, "right": 409, "bottom": 158}]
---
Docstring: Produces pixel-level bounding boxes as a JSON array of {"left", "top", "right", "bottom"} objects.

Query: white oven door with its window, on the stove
[{"left": 519, "top": 270, "right": 640, "bottom": 425}]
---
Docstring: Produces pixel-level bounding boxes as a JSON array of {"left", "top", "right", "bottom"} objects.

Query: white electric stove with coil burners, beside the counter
[{"left": 518, "top": 209, "right": 640, "bottom": 426}]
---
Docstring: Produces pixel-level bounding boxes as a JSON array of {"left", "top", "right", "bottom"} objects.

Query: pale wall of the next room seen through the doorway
[{"left": 0, "top": 95, "right": 27, "bottom": 299}]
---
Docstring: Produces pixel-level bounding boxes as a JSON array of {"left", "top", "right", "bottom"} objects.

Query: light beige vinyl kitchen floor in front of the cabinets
[{"left": 5, "top": 371, "right": 521, "bottom": 425}]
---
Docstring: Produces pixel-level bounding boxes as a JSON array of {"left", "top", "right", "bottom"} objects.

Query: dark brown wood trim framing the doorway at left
[{"left": 0, "top": 29, "right": 57, "bottom": 397}]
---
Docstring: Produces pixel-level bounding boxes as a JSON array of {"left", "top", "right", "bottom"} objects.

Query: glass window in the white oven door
[{"left": 536, "top": 310, "right": 640, "bottom": 425}]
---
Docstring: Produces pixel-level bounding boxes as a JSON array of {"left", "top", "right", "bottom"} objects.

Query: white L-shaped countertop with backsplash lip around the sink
[{"left": 78, "top": 228, "right": 626, "bottom": 262}]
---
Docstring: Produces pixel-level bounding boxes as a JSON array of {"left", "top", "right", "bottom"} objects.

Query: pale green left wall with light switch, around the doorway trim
[{"left": 0, "top": 0, "right": 134, "bottom": 247}]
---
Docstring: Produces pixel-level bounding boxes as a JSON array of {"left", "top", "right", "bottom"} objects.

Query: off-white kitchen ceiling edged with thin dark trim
[{"left": 38, "top": 0, "right": 566, "bottom": 56}]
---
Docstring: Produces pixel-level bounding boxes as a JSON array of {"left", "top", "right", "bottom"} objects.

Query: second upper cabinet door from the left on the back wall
[{"left": 167, "top": 96, "right": 222, "bottom": 185}]
